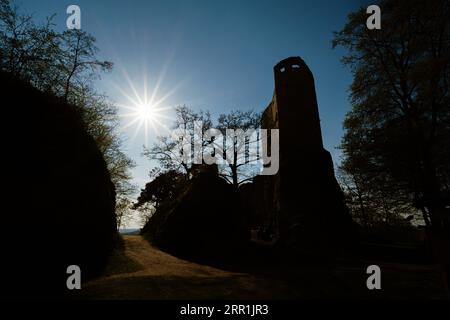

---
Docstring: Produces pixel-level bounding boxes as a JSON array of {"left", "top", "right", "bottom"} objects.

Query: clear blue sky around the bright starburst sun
[{"left": 19, "top": 0, "right": 370, "bottom": 228}]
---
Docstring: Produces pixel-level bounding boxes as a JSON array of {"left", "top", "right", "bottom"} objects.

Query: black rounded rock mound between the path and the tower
[{"left": 142, "top": 166, "right": 250, "bottom": 257}]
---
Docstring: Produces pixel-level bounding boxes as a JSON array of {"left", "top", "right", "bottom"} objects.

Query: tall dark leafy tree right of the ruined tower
[{"left": 333, "top": 0, "right": 450, "bottom": 228}]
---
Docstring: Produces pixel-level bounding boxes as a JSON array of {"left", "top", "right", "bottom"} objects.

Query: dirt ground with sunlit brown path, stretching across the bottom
[{"left": 77, "top": 236, "right": 445, "bottom": 299}]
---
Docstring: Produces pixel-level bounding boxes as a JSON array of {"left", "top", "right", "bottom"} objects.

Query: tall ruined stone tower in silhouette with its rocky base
[{"left": 254, "top": 57, "right": 353, "bottom": 255}]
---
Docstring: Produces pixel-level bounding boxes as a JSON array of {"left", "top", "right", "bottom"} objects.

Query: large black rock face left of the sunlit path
[{"left": 0, "top": 74, "right": 116, "bottom": 298}]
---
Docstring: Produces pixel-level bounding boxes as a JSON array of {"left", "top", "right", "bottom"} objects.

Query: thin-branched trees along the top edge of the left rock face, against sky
[{"left": 0, "top": 0, "right": 134, "bottom": 199}]
